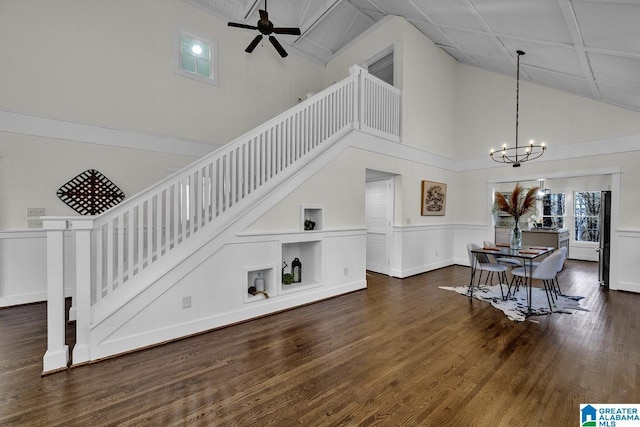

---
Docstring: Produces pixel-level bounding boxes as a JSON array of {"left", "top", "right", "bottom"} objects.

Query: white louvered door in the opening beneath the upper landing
[{"left": 366, "top": 171, "right": 394, "bottom": 275}]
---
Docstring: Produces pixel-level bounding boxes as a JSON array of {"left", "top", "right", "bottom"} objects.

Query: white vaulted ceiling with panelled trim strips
[{"left": 185, "top": 0, "right": 640, "bottom": 111}]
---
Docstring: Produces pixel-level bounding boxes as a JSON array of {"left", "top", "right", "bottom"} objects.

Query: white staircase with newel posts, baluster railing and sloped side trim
[{"left": 44, "top": 66, "right": 400, "bottom": 372}]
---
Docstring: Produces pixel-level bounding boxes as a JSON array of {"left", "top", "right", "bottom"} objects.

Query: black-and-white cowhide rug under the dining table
[{"left": 439, "top": 285, "right": 589, "bottom": 322}]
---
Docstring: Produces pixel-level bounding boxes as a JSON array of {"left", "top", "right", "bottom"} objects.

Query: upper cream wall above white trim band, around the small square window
[{"left": 0, "top": 0, "right": 322, "bottom": 144}]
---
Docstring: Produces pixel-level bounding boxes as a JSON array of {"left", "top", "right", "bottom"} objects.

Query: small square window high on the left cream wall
[{"left": 177, "top": 31, "right": 218, "bottom": 85}]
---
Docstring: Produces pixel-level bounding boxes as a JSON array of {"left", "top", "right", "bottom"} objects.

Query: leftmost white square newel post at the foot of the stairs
[{"left": 42, "top": 217, "right": 69, "bottom": 373}]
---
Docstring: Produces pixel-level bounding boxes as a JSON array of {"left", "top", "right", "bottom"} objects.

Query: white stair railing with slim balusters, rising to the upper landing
[{"left": 91, "top": 66, "right": 400, "bottom": 304}]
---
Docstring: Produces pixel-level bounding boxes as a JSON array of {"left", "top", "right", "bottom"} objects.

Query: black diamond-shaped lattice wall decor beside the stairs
[{"left": 57, "top": 169, "right": 124, "bottom": 215}]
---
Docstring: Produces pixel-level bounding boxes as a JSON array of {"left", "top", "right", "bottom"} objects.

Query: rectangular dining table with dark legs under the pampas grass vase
[{"left": 469, "top": 244, "right": 555, "bottom": 314}]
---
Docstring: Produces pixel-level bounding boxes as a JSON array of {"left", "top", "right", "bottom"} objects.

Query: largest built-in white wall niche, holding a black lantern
[{"left": 280, "top": 240, "right": 322, "bottom": 294}]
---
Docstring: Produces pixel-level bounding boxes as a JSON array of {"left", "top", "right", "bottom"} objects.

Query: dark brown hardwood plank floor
[{"left": 0, "top": 261, "right": 640, "bottom": 426}]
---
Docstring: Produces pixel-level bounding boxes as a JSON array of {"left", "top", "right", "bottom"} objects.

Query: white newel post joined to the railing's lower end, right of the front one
[{"left": 71, "top": 217, "right": 93, "bottom": 365}]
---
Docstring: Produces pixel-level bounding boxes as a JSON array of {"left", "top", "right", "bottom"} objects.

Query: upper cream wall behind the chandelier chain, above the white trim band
[{"left": 455, "top": 64, "right": 640, "bottom": 159}]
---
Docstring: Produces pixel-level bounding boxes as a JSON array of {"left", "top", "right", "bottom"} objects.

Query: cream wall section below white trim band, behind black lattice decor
[{"left": 0, "top": 132, "right": 195, "bottom": 230}]
